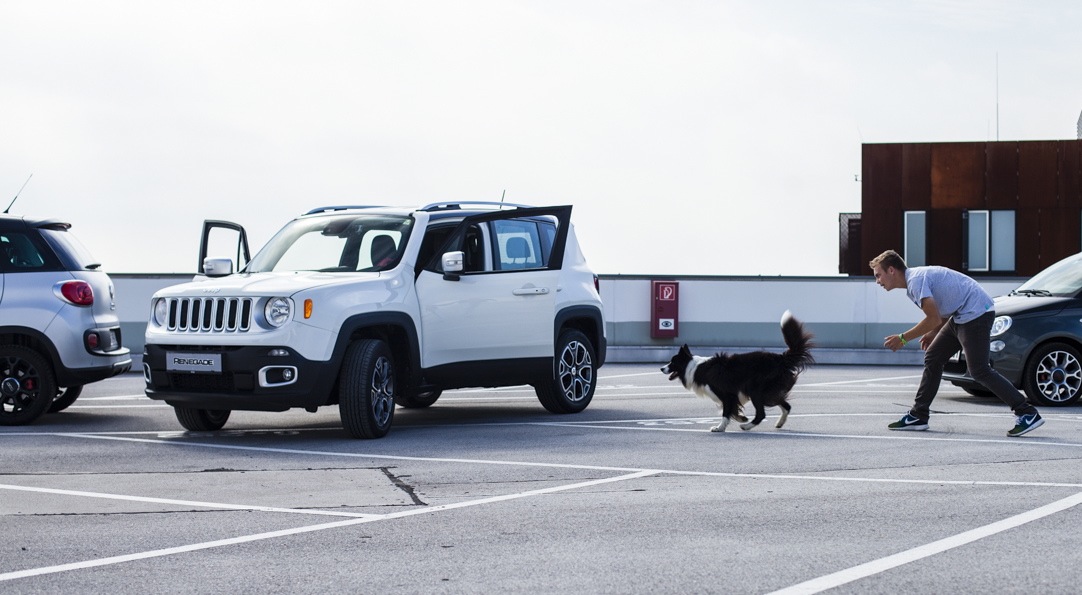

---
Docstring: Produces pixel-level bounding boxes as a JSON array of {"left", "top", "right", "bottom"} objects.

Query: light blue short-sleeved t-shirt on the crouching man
[{"left": 906, "top": 266, "right": 993, "bottom": 325}]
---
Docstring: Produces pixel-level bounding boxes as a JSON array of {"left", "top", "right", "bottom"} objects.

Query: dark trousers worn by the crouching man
[{"left": 910, "top": 310, "right": 1037, "bottom": 420}]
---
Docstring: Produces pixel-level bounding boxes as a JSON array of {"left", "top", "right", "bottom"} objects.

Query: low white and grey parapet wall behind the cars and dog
[{"left": 111, "top": 274, "right": 1025, "bottom": 368}]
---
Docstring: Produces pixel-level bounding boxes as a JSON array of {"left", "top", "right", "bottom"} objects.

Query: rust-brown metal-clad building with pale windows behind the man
[{"left": 839, "top": 140, "right": 1082, "bottom": 277}]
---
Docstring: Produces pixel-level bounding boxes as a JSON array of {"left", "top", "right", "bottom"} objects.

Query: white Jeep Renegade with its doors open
[{"left": 143, "top": 202, "right": 606, "bottom": 438}]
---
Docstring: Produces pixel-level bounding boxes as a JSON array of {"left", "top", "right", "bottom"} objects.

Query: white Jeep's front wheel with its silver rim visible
[{"left": 339, "top": 339, "right": 395, "bottom": 438}]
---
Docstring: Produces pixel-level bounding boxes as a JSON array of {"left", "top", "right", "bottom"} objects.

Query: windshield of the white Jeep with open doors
[{"left": 247, "top": 213, "right": 413, "bottom": 273}]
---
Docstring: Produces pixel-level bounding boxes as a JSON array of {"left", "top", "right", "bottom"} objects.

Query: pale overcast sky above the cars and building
[{"left": 0, "top": 0, "right": 1082, "bottom": 276}]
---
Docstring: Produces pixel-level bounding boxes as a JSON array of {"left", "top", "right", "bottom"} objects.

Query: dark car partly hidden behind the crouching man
[{"left": 944, "top": 253, "right": 1082, "bottom": 406}]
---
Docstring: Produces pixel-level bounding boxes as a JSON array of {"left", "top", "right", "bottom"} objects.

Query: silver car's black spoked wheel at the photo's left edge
[{"left": 0, "top": 345, "right": 56, "bottom": 425}]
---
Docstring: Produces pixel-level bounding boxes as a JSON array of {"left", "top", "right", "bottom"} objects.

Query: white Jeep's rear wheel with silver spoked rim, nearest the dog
[{"left": 533, "top": 329, "right": 597, "bottom": 413}]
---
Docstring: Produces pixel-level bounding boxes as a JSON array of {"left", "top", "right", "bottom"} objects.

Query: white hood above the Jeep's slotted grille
[{"left": 155, "top": 270, "right": 385, "bottom": 298}]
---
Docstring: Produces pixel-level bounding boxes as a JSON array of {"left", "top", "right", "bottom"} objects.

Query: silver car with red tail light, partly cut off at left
[{"left": 0, "top": 214, "right": 132, "bottom": 425}]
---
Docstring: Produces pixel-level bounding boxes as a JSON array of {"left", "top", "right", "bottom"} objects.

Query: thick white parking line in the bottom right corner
[{"left": 771, "top": 493, "right": 1082, "bottom": 595}]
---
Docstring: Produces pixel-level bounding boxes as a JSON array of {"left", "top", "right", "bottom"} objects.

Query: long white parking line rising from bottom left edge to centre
[{"left": 0, "top": 471, "right": 655, "bottom": 582}]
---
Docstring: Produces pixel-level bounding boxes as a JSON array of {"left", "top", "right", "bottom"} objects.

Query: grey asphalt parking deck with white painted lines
[{"left": 0, "top": 365, "right": 1082, "bottom": 594}]
